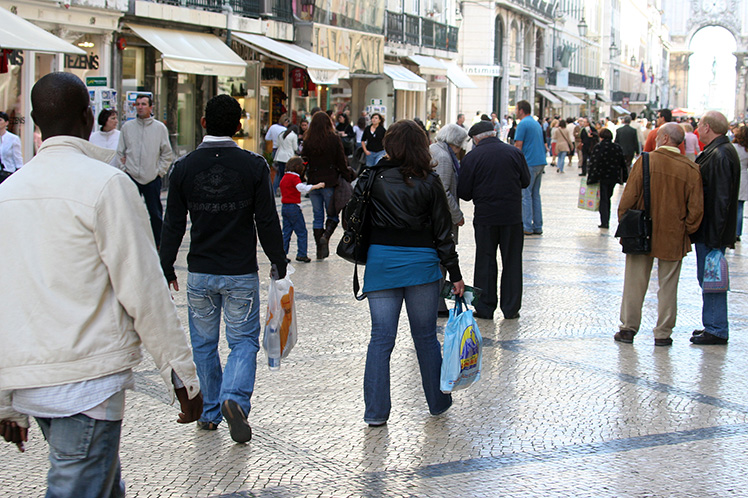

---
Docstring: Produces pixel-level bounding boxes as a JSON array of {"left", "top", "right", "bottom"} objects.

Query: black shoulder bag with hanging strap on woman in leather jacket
[{"left": 335, "top": 170, "right": 376, "bottom": 301}]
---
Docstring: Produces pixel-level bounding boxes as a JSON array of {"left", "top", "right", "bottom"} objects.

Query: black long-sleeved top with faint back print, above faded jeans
[{"left": 160, "top": 139, "right": 286, "bottom": 281}]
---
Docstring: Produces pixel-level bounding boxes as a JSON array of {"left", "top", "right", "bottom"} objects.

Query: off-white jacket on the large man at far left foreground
[{"left": 0, "top": 136, "right": 200, "bottom": 419}]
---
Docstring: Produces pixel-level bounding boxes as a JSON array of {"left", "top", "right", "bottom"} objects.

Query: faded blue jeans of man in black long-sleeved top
[{"left": 187, "top": 272, "right": 260, "bottom": 424}]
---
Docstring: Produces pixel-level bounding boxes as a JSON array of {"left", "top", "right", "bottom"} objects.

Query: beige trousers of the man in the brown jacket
[{"left": 620, "top": 254, "right": 682, "bottom": 339}]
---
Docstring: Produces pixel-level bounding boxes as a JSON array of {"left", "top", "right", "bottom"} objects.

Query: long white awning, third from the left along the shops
[{"left": 232, "top": 31, "right": 350, "bottom": 85}]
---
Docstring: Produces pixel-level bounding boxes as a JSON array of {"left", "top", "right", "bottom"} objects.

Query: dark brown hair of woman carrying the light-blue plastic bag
[{"left": 384, "top": 119, "right": 433, "bottom": 185}]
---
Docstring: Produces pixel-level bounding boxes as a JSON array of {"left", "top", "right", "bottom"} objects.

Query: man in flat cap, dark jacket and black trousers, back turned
[{"left": 457, "top": 121, "right": 530, "bottom": 320}]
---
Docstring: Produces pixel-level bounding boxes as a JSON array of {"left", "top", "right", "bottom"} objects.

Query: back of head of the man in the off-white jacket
[{"left": 31, "top": 73, "right": 94, "bottom": 140}]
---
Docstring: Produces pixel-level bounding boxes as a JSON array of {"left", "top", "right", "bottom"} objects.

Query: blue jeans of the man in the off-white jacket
[{"left": 36, "top": 413, "right": 125, "bottom": 498}]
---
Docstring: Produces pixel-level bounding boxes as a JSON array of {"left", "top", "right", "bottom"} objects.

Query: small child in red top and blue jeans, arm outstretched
[{"left": 280, "top": 156, "right": 325, "bottom": 263}]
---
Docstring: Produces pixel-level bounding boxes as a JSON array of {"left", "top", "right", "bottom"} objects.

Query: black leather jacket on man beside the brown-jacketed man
[{"left": 691, "top": 136, "right": 740, "bottom": 248}]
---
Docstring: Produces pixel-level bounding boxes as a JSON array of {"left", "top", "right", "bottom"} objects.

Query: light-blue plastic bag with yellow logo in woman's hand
[{"left": 439, "top": 298, "right": 483, "bottom": 393}]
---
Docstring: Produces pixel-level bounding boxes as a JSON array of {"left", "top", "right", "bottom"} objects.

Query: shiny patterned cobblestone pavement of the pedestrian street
[{"left": 0, "top": 158, "right": 748, "bottom": 498}]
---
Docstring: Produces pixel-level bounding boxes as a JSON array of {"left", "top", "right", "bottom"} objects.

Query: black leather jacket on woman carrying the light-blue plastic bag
[{"left": 356, "top": 159, "right": 462, "bottom": 282}]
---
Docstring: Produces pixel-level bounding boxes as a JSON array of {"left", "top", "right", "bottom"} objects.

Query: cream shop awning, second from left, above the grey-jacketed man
[{"left": 127, "top": 24, "right": 247, "bottom": 77}]
